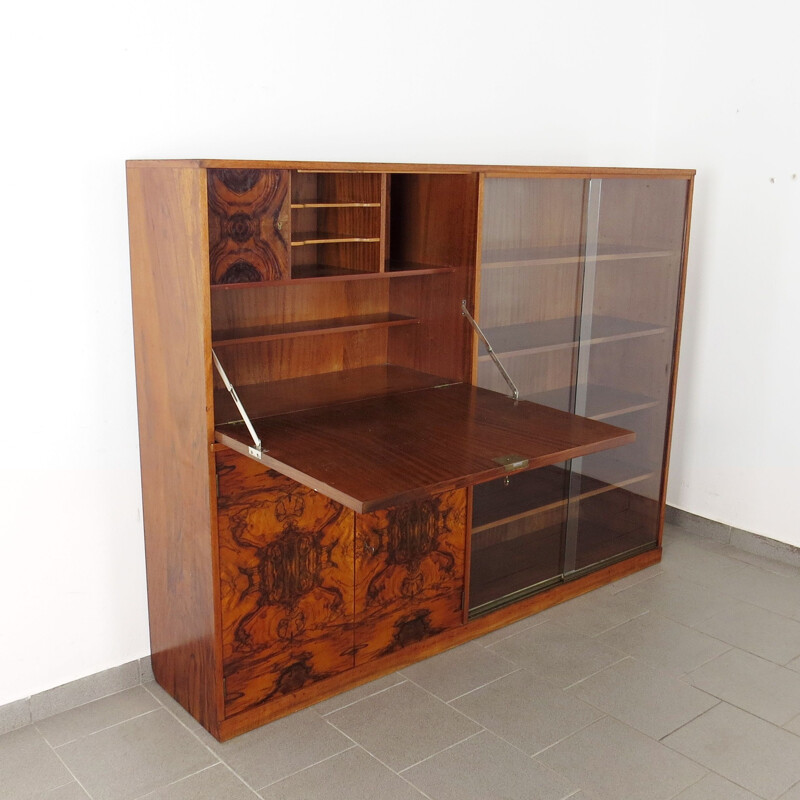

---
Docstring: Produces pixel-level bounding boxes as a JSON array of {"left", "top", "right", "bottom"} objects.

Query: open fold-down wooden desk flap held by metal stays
[{"left": 216, "top": 383, "right": 635, "bottom": 513}]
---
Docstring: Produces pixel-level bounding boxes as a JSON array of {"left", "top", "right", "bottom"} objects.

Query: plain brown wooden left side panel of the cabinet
[{"left": 128, "top": 168, "right": 219, "bottom": 732}]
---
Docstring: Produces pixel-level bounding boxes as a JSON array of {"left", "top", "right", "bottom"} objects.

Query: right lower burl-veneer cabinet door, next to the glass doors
[{"left": 355, "top": 489, "right": 466, "bottom": 664}]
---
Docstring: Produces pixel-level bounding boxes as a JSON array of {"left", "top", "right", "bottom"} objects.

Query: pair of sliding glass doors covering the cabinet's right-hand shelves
[{"left": 469, "top": 177, "right": 689, "bottom": 616}]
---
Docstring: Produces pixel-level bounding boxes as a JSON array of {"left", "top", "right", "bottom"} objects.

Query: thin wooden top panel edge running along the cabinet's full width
[{"left": 127, "top": 158, "right": 695, "bottom": 178}]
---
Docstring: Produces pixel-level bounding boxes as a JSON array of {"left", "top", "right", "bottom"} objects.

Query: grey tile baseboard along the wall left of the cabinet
[{"left": 0, "top": 656, "right": 153, "bottom": 735}]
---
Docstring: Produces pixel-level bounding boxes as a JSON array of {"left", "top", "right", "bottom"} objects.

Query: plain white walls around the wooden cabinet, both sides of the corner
[{"left": 0, "top": 0, "right": 800, "bottom": 704}]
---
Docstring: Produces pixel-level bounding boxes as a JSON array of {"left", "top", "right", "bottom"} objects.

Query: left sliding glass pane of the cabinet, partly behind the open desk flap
[{"left": 470, "top": 178, "right": 587, "bottom": 610}]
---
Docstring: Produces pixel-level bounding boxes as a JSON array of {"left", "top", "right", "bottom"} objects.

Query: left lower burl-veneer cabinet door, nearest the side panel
[{"left": 217, "top": 452, "right": 354, "bottom": 716}]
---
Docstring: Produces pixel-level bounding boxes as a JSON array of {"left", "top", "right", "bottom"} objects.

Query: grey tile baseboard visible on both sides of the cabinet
[{"left": 0, "top": 506, "right": 800, "bottom": 735}]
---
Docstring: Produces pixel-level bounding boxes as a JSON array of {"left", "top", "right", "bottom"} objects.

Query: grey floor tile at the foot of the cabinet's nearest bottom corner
[{"left": 209, "top": 708, "right": 353, "bottom": 791}]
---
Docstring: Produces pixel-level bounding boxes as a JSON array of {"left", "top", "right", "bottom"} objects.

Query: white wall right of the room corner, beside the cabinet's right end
[{"left": 655, "top": 0, "right": 800, "bottom": 546}]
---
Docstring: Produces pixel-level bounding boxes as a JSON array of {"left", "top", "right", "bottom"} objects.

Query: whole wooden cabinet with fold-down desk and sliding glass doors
[{"left": 128, "top": 161, "right": 693, "bottom": 739}]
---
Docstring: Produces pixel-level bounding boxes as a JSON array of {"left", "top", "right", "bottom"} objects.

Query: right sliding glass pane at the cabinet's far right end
[{"left": 566, "top": 178, "right": 688, "bottom": 571}]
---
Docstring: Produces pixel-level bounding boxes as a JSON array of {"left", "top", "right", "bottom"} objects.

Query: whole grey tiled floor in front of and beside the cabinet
[{"left": 0, "top": 526, "right": 800, "bottom": 800}]
